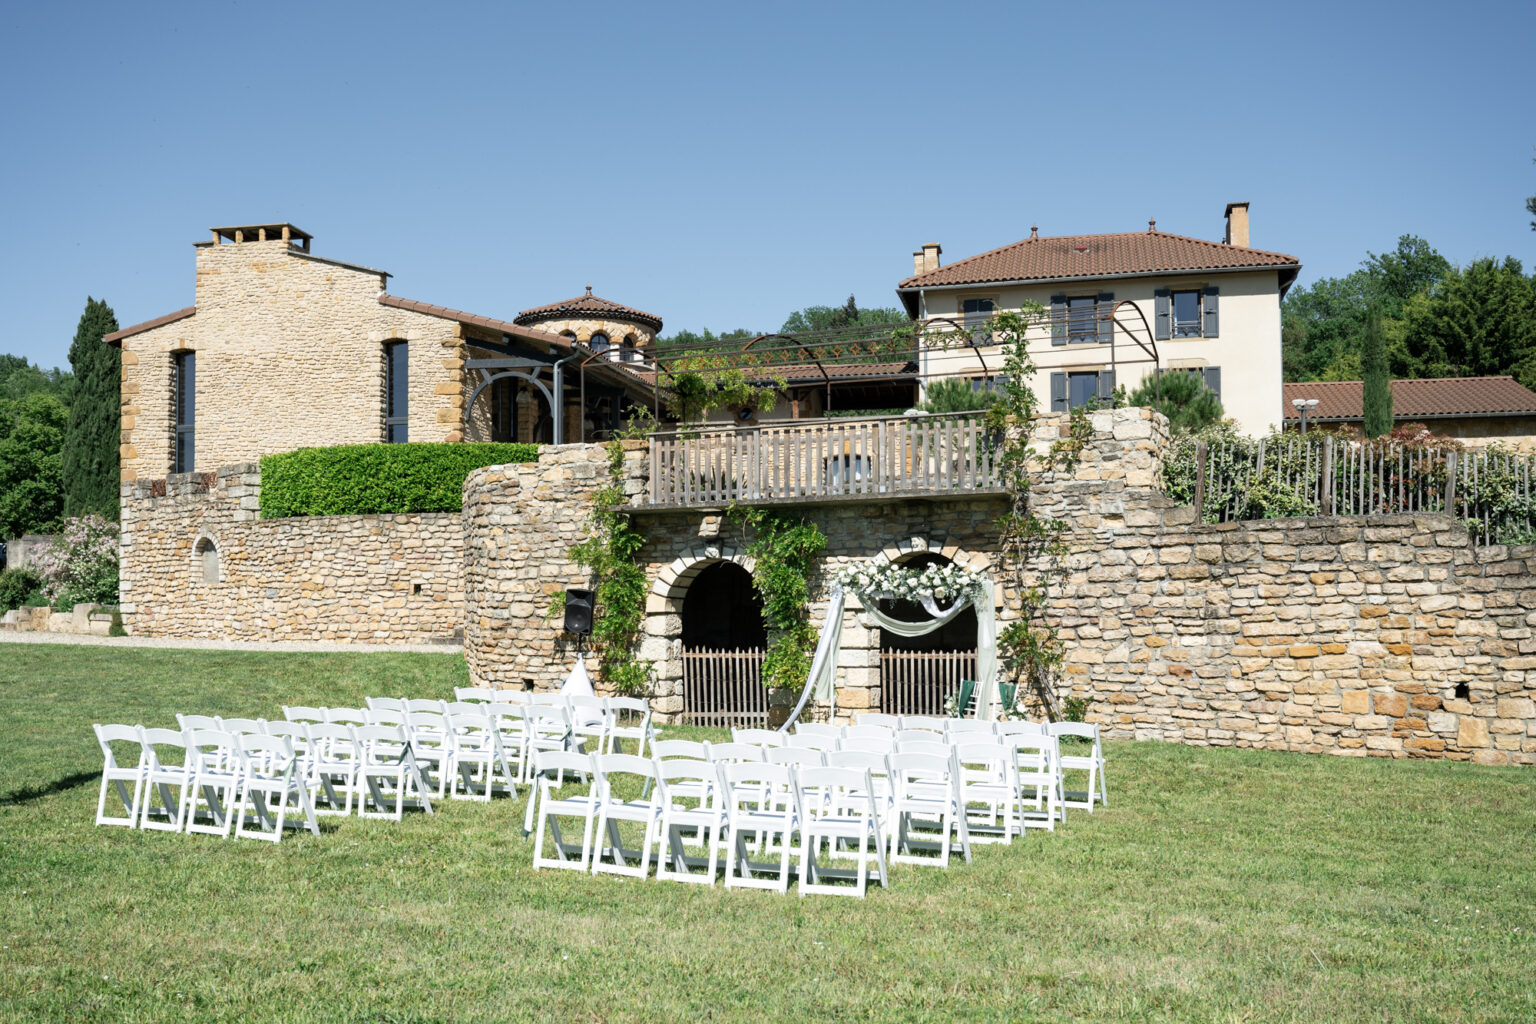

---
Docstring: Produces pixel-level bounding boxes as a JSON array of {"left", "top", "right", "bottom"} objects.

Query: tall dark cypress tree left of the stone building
[{"left": 65, "top": 298, "right": 123, "bottom": 520}]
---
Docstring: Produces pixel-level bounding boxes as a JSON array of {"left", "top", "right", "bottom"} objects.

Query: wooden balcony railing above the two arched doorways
[{"left": 647, "top": 413, "right": 1000, "bottom": 507}]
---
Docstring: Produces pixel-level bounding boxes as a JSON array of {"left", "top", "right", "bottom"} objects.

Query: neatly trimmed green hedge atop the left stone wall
[{"left": 261, "top": 444, "right": 539, "bottom": 519}]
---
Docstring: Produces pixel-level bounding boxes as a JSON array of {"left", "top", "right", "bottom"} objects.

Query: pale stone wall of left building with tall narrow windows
[{"left": 121, "top": 241, "right": 465, "bottom": 481}]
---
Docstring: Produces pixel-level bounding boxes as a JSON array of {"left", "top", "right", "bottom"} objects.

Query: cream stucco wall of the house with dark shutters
[{"left": 923, "top": 270, "right": 1283, "bottom": 434}]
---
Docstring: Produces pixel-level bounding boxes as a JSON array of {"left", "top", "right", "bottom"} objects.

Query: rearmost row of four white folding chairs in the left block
[{"left": 95, "top": 725, "right": 319, "bottom": 841}]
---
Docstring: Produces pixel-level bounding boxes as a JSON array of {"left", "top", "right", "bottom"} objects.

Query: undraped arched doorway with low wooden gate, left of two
[{"left": 682, "top": 562, "right": 768, "bottom": 728}]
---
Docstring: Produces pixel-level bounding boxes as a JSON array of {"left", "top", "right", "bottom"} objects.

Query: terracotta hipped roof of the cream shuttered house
[{"left": 895, "top": 230, "right": 1301, "bottom": 290}]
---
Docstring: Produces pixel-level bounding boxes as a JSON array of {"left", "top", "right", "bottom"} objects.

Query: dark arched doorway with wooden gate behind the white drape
[{"left": 880, "top": 553, "right": 975, "bottom": 715}]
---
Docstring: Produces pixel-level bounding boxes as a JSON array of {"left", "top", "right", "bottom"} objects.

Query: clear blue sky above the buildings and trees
[{"left": 0, "top": 0, "right": 1536, "bottom": 365}]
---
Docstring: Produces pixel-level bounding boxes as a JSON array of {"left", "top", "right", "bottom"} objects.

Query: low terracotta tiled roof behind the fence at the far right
[{"left": 1283, "top": 376, "right": 1536, "bottom": 424}]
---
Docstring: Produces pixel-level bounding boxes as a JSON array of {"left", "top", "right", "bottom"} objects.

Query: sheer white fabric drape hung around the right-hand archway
[{"left": 779, "top": 583, "right": 998, "bottom": 732}]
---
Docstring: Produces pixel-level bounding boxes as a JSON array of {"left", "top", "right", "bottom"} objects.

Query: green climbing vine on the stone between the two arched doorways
[{"left": 731, "top": 508, "right": 826, "bottom": 691}]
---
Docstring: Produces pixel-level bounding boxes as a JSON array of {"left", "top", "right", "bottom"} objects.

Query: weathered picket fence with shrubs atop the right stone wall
[{"left": 1164, "top": 438, "right": 1536, "bottom": 543}]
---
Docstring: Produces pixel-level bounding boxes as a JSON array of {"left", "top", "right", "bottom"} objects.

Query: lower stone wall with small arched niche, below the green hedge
[{"left": 121, "top": 464, "right": 464, "bottom": 643}]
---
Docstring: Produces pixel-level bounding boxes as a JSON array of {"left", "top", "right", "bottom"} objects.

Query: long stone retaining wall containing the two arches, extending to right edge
[{"left": 465, "top": 410, "right": 1536, "bottom": 763}]
